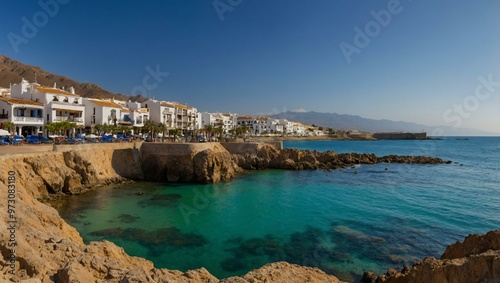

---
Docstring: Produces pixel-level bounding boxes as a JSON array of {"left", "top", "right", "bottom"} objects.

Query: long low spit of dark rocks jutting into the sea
[{"left": 229, "top": 145, "right": 450, "bottom": 170}]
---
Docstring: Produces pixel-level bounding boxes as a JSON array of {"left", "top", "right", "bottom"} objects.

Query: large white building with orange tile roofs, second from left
[{"left": 11, "top": 79, "right": 85, "bottom": 134}]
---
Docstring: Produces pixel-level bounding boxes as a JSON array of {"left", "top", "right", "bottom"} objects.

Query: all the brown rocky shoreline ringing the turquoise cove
[{"left": 0, "top": 144, "right": 500, "bottom": 283}]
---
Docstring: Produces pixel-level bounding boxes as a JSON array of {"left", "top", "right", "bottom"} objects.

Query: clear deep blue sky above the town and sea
[{"left": 0, "top": 0, "right": 500, "bottom": 133}]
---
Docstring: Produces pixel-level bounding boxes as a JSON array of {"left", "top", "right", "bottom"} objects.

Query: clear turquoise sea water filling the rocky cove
[{"left": 59, "top": 138, "right": 500, "bottom": 281}]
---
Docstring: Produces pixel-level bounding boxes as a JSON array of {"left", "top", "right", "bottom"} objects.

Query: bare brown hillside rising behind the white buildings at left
[{"left": 0, "top": 55, "right": 146, "bottom": 102}]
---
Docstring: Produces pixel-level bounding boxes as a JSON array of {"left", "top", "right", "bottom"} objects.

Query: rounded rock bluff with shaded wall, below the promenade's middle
[{"left": 141, "top": 143, "right": 241, "bottom": 183}]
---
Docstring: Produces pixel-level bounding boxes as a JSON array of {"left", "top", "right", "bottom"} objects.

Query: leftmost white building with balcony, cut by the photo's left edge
[{"left": 0, "top": 97, "right": 44, "bottom": 135}]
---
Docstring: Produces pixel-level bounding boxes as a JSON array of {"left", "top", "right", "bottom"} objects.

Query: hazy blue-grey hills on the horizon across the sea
[{"left": 271, "top": 111, "right": 498, "bottom": 136}]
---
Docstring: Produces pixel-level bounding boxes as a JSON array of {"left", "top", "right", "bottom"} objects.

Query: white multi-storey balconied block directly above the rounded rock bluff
[{"left": 142, "top": 99, "right": 198, "bottom": 133}]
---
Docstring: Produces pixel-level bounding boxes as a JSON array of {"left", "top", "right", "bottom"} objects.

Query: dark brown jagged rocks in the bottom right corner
[{"left": 363, "top": 230, "right": 500, "bottom": 283}]
